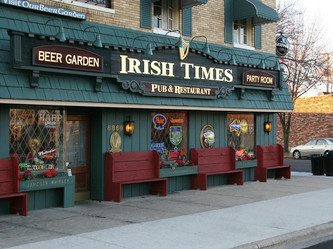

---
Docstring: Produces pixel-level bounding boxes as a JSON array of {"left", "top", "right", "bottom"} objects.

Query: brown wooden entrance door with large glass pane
[{"left": 66, "top": 115, "right": 90, "bottom": 201}]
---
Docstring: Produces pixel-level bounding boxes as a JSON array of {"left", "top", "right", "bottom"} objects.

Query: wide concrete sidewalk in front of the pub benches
[{"left": 0, "top": 173, "right": 333, "bottom": 249}]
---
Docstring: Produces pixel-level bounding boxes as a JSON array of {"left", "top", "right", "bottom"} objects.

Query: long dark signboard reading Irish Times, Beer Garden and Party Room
[{"left": 9, "top": 31, "right": 281, "bottom": 99}]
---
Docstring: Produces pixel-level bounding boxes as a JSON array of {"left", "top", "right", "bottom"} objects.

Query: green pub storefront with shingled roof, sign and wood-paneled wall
[{"left": 0, "top": 1, "right": 293, "bottom": 209}]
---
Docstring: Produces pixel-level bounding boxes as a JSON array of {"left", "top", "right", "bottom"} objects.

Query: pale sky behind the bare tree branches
[{"left": 276, "top": 0, "right": 333, "bottom": 97}]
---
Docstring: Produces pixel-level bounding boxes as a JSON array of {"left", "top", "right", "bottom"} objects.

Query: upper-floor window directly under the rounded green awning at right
[{"left": 233, "top": 19, "right": 253, "bottom": 46}]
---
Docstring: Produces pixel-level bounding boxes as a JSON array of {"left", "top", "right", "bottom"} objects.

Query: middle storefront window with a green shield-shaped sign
[{"left": 151, "top": 112, "right": 187, "bottom": 162}]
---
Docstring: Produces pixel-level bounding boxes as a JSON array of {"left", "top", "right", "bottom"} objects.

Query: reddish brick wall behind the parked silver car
[{"left": 276, "top": 113, "right": 333, "bottom": 149}]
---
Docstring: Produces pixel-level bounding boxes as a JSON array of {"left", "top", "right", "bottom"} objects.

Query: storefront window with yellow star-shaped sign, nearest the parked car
[{"left": 228, "top": 114, "right": 255, "bottom": 160}]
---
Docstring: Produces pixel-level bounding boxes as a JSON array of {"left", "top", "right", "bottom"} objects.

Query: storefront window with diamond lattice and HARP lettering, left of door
[{"left": 9, "top": 109, "right": 65, "bottom": 171}]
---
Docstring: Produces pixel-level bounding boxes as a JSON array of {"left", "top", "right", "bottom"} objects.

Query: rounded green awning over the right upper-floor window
[{"left": 233, "top": 0, "right": 279, "bottom": 25}]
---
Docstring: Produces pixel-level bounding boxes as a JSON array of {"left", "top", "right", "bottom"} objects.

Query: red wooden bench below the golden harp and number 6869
[{"left": 104, "top": 151, "right": 168, "bottom": 202}]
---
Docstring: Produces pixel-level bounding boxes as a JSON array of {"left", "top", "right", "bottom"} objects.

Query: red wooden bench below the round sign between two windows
[{"left": 191, "top": 147, "right": 243, "bottom": 190}]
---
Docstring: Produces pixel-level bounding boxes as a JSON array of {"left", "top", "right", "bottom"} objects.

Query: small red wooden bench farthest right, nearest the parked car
[{"left": 255, "top": 144, "right": 291, "bottom": 182}]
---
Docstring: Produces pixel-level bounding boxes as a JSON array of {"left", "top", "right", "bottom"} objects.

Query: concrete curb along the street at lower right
[{"left": 232, "top": 221, "right": 333, "bottom": 249}]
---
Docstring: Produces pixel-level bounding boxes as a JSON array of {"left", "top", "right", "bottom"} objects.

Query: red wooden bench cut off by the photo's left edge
[{"left": 0, "top": 157, "right": 28, "bottom": 216}]
